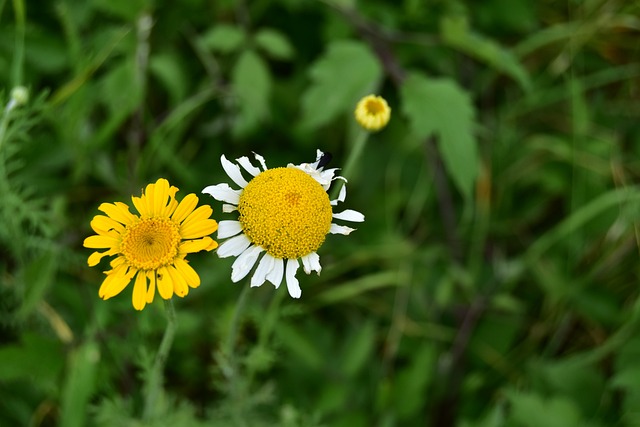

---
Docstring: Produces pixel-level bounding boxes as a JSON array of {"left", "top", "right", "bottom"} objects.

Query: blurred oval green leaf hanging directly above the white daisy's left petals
[{"left": 231, "top": 50, "right": 271, "bottom": 136}]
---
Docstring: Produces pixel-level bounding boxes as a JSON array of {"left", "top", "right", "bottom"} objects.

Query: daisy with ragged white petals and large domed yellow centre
[{"left": 202, "top": 150, "right": 364, "bottom": 298}]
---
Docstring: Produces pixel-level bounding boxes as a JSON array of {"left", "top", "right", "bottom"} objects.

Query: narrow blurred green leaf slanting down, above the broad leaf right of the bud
[{"left": 440, "top": 16, "right": 531, "bottom": 91}]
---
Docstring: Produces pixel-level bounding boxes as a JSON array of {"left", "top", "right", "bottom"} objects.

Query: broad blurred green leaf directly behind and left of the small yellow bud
[{"left": 301, "top": 41, "right": 382, "bottom": 130}]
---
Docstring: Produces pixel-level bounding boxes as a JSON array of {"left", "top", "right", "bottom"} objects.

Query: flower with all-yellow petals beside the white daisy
[{"left": 83, "top": 178, "right": 218, "bottom": 310}]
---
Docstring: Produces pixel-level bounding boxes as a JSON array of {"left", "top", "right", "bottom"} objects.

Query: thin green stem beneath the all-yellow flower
[{"left": 142, "top": 299, "right": 176, "bottom": 421}]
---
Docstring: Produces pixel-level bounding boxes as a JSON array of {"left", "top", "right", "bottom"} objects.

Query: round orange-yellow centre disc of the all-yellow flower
[{"left": 120, "top": 218, "right": 181, "bottom": 270}]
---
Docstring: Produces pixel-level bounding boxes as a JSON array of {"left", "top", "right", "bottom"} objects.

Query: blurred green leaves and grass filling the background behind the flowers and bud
[{"left": 0, "top": 0, "right": 640, "bottom": 427}]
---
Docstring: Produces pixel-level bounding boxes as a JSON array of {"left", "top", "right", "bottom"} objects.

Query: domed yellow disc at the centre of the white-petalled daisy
[{"left": 238, "top": 168, "right": 333, "bottom": 259}]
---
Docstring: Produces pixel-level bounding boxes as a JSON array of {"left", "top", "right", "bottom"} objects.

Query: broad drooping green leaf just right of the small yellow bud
[{"left": 400, "top": 73, "right": 479, "bottom": 199}]
